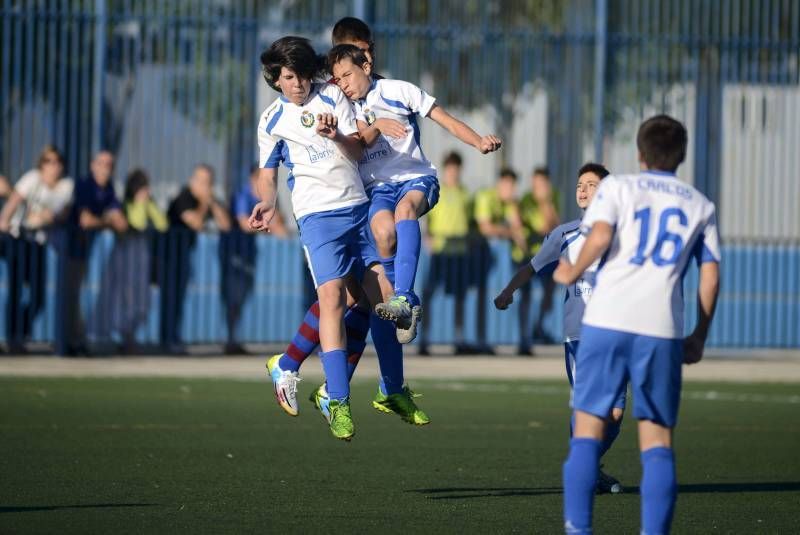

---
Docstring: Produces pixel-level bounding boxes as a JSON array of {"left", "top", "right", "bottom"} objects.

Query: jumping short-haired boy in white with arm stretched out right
[{"left": 328, "top": 45, "right": 501, "bottom": 343}]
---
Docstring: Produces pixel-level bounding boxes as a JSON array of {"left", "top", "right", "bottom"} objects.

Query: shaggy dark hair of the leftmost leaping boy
[{"left": 261, "top": 35, "right": 325, "bottom": 91}]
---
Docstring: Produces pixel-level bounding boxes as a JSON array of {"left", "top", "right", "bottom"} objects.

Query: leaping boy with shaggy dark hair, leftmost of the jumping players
[{"left": 250, "top": 37, "right": 402, "bottom": 440}]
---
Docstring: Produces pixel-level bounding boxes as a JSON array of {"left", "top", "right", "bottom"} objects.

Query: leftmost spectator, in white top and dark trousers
[{"left": 0, "top": 145, "right": 74, "bottom": 353}]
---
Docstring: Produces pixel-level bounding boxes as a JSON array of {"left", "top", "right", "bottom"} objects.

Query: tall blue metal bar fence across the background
[{"left": 0, "top": 0, "right": 800, "bottom": 356}]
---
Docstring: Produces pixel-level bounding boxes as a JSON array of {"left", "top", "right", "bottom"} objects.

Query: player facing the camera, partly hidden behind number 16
[{"left": 494, "top": 163, "right": 625, "bottom": 494}]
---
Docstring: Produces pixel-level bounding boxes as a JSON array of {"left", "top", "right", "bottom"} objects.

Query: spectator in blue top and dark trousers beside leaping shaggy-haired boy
[{"left": 219, "top": 165, "right": 287, "bottom": 355}]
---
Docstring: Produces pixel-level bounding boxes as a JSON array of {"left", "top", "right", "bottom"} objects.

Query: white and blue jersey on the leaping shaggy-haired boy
[{"left": 258, "top": 83, "right": 368, "bottom": 219}]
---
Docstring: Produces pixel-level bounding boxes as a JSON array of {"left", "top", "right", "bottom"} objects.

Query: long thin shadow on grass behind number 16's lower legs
[{"left": 406, "top": 481, "right": 800, "bottom": 500}]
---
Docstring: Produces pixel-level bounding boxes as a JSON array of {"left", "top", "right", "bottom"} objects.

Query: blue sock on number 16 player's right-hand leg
[{"left": 639, "top": 447, "right": 678, "bottom": 535}]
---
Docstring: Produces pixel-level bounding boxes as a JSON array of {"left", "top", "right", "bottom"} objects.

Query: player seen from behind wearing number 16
[{"left": 553, "top": 115, "right": 720, "bottom": 535}]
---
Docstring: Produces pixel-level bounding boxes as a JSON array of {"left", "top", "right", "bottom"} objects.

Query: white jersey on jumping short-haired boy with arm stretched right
[{"left": 353, "top": 79, "right": 436, "bottom": 188}]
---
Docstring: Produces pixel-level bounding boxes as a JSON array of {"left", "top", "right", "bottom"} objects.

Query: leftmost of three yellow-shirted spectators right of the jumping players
[{"left": 419, "top": 152, "right": 472, "bottom": 355}]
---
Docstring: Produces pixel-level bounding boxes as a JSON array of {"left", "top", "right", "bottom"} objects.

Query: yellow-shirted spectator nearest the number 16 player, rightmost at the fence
[{"left": 514, "top": 167, "right": 561, "bottom": 355}]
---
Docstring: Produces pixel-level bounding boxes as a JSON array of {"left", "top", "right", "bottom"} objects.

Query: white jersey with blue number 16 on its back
[{"left": 582, "top": 171, "right": 720, "bottom": 339}]
